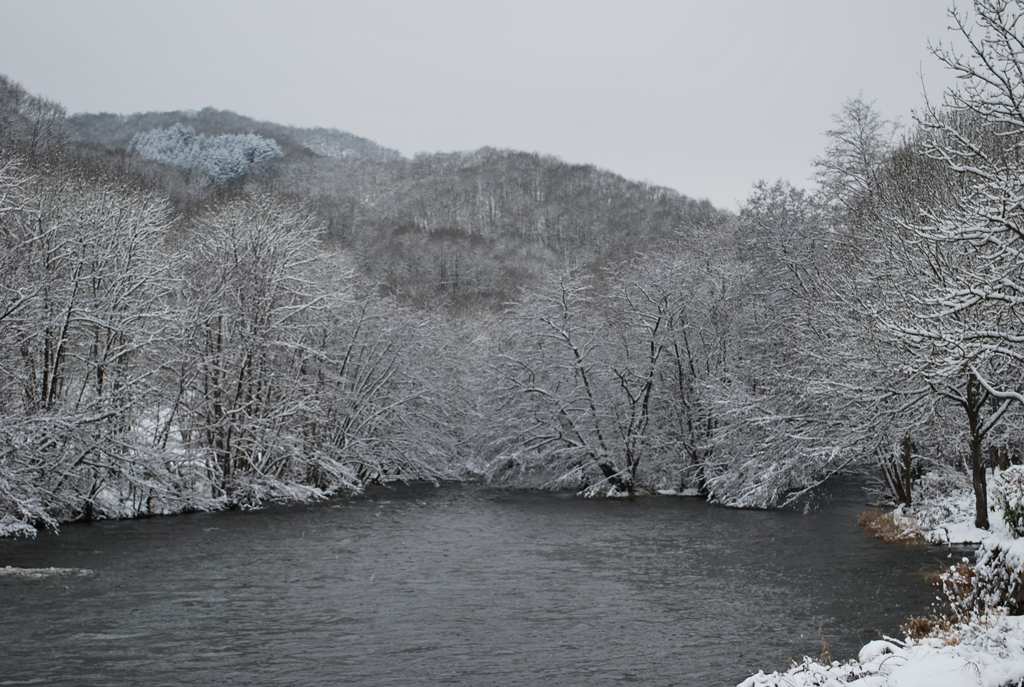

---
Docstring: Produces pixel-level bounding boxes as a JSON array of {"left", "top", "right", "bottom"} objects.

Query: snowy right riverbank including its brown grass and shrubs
[{"left": 739, "top": 479, "right": 1024, "bottom": 687}]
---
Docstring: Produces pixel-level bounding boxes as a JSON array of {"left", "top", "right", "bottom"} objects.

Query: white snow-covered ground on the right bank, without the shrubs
[{"left": 739, "top": 475, "right": 1024, "bottom": 687}]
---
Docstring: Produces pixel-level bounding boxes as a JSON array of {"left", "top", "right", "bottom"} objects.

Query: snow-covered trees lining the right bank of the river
[{"left": 479, "top": 0, "right": 1024, "bottom": 527}]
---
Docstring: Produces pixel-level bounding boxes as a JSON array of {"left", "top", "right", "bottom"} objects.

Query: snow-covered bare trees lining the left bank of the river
[{"left": 0, "top": 79, "right": 461, "bottom": 534}]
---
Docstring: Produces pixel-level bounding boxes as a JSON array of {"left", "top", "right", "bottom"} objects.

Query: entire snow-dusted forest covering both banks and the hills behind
[{"left": 6, "top": 3, "right": 1024, "bottom": 534}]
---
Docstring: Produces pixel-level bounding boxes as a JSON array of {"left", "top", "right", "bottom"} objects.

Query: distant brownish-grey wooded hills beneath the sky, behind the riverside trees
[{"left": 73, "top": 109, "right": 721, "bottom": 309}]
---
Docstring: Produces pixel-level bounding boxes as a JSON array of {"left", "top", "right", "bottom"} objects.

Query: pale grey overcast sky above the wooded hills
[{"left": 0, "top": 0, "right": 951, "bottom": 209}]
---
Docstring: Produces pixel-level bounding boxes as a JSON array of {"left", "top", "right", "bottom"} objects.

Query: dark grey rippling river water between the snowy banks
[{"left": 0, "top": 485, "right": 958, "bottom": 687}]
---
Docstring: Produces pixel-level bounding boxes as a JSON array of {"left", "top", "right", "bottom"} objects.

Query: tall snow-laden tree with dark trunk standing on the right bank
[{"left": 856, "top": 0, "right": 1024, "bottom": 527}]
